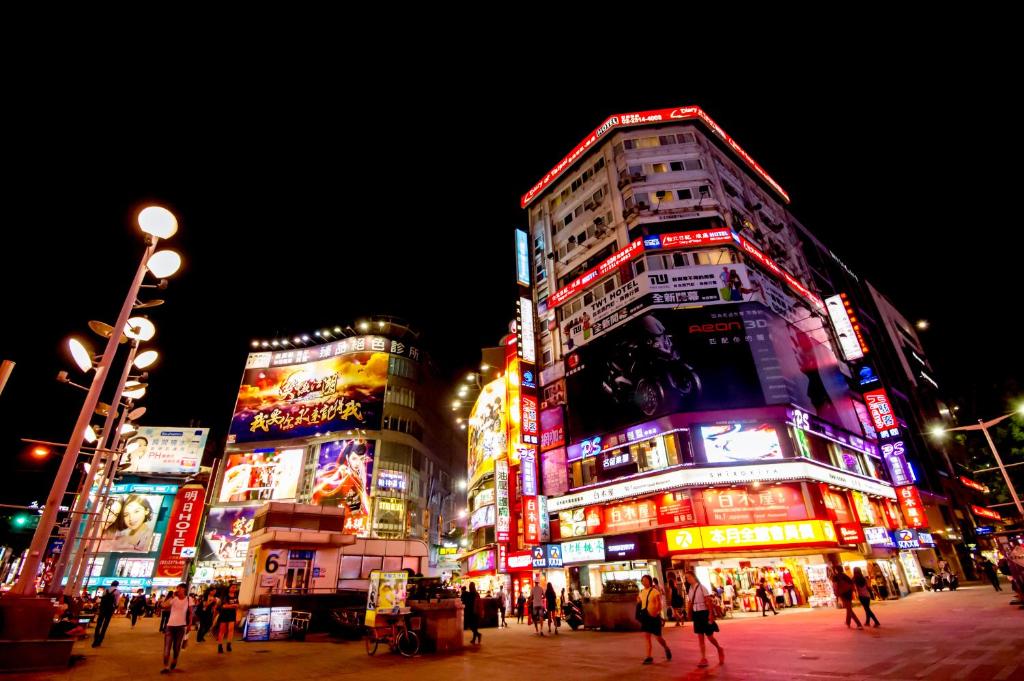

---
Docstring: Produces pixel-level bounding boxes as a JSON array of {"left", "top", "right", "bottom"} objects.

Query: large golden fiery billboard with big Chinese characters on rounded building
[{"left": 227, "top": 346, "right": 388, "bottom": 444}]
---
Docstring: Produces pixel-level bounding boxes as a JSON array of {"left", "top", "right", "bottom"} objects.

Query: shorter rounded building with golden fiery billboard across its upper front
[{"left": 198, "top": 316, "right": 465, "bottom": 589}]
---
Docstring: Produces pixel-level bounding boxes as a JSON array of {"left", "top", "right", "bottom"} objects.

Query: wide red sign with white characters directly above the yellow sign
[{"left": 703, "top": 484, "right": 807, "bottom": 525}]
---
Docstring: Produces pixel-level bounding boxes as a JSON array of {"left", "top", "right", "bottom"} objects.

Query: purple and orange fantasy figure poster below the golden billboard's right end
[{"left": 311, "top": 437, "right": 376, "bottom": 537}]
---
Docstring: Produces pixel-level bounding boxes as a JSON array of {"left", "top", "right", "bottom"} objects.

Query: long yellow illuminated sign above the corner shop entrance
[{"left": 666, "top": 520, "right": 837, "bottom": 553}]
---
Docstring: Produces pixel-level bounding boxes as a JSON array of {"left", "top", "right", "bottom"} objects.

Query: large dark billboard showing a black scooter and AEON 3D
[{"left": 565, "top": 303, "right": 857, "bottom": 442}]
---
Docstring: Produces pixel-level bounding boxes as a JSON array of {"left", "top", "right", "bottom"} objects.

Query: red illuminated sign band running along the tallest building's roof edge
[{"left": 519, "top": 107, "right": 790, "bottom": 208}]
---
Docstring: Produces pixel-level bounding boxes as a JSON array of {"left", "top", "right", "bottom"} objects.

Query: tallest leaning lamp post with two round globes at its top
[{"left": 11, "top": 206, "right": 180, "bottom": 596}]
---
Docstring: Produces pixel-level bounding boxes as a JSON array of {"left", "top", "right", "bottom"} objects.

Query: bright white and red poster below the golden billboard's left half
[{"left": 219, "top": 450, "right": 305, "bottom": 503}]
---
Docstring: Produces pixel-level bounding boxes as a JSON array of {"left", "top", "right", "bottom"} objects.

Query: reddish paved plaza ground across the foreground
[{"left": 9, "top": 586, "right": 1024, "bottom": 681}]
